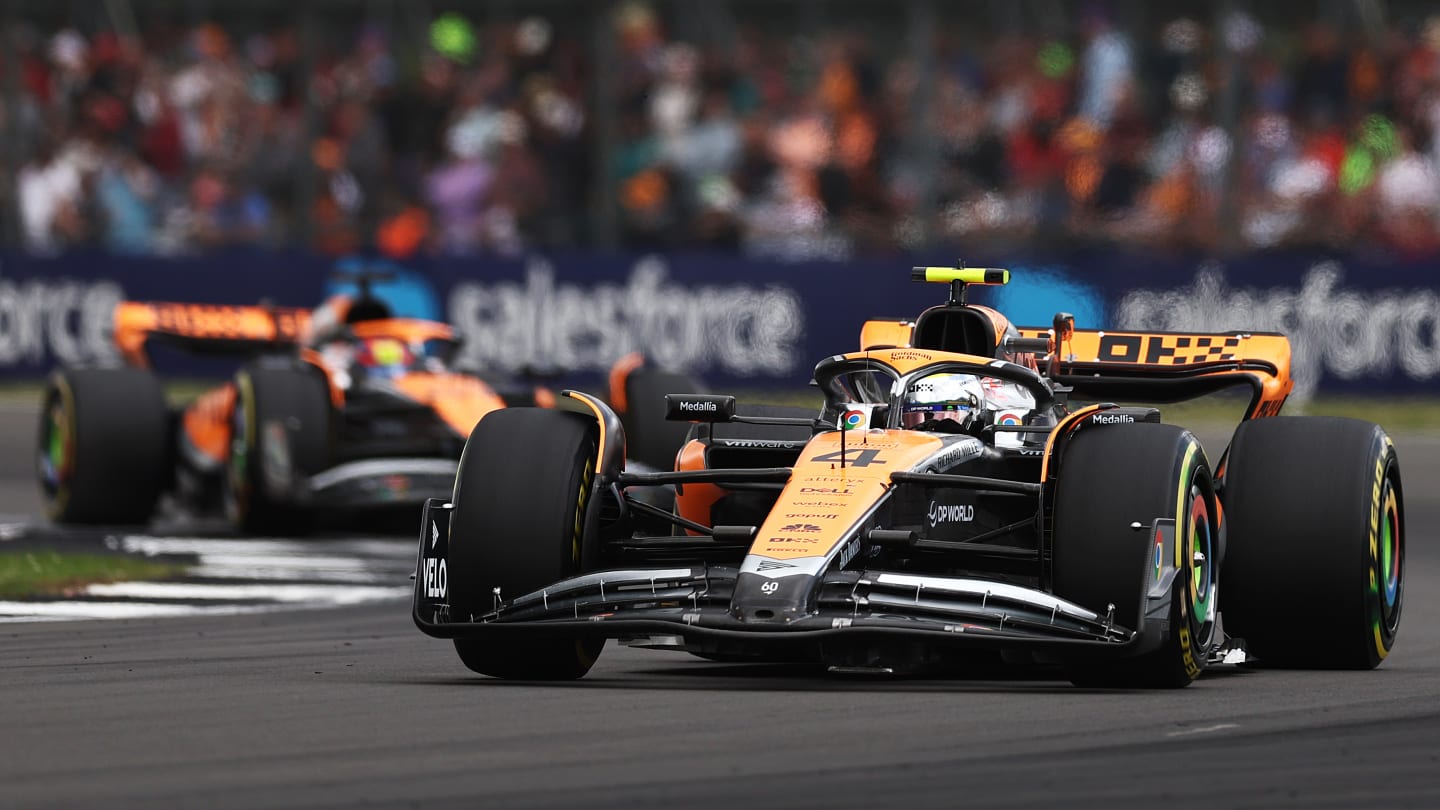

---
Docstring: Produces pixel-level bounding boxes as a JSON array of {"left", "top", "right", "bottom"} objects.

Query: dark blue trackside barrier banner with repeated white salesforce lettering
[{"left": 0, "top": 252, "right": 1440, "bottom": 396}]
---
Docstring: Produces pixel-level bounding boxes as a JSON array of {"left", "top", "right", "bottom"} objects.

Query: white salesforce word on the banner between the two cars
[{"left": 446, "top": 257, "right": 805, "bottom": 376}]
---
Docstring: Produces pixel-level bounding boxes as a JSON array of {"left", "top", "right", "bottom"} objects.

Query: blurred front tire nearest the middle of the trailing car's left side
[{"left": 223, "top": 365, "right": 333, "bottom": 535}]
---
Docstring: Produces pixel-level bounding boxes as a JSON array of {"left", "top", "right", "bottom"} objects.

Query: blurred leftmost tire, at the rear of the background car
[{"left": 36, "top": 368, "right": 171, "bottom": 525}]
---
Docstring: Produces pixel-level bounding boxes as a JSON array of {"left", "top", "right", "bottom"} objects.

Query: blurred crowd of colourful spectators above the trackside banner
[{"left": 8, "top": 1, "right": 1440, "bottom": 258}]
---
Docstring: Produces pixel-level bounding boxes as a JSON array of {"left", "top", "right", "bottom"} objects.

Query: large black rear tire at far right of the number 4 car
[{"left": 1223, "top": 417, "right": 1405, "bottom": 669}]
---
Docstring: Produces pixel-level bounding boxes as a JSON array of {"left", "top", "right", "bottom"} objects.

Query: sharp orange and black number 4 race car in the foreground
[{"left": 413, "top": 268, "right": 1404, "bottom": 687}]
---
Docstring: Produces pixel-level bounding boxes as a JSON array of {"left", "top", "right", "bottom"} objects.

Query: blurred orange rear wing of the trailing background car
[{"left": 114, "top": 301, "right": 310, "bottom": 368}]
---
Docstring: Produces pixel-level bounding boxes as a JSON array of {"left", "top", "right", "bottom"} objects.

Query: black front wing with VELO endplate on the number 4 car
[{"left": 413, "top": 499, "right": 1178, "bottom": 657}]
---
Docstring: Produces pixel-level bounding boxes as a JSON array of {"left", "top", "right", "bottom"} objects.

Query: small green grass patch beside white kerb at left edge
[{"left": 0, "top": 551, "right": 184, "bottom": 600}]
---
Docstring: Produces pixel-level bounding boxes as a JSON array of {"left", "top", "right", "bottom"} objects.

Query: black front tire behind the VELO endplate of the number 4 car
[{"left": 448, "top": 408, "right": 605, "bottom": 680}]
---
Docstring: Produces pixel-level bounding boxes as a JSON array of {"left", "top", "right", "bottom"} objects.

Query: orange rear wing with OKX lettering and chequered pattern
[{"left": 1020, "top": 326, "right": 1295, "bottom": 418}]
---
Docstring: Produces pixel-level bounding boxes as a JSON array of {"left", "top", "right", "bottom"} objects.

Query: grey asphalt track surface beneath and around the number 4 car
[{"left": 0, "top": 403, "right": 1440, "bottom": 810}]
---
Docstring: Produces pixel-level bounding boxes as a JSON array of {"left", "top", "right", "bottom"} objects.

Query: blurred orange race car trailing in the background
[{"left": 36, "top": 274, "right": 584, "bottom": 533}]
